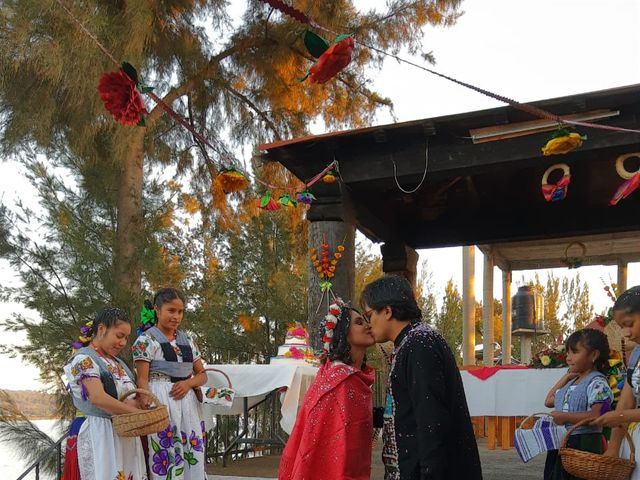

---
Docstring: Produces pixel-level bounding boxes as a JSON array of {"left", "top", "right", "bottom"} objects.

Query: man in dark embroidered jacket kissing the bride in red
[{"left": 361, "top": 276, "right": 482, "bottom": 480}]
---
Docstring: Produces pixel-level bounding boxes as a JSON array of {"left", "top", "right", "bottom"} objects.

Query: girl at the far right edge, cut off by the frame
[{"left": 593, "top": 285, "right": 640, "bottom": 480}]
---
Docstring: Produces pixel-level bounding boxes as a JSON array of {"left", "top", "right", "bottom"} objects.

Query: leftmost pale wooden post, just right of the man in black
[{"left": 462, "top": 245, "right": 476, "bottom": 365}]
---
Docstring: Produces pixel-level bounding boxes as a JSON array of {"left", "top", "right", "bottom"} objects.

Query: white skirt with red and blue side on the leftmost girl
[{"left": 63, "top": 416, "right": 147, "bottom": 480}]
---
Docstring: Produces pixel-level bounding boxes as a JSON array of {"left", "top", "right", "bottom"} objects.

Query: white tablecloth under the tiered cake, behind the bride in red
[{"left": 203, "top": 364, "right": 318, "bottom": 433}]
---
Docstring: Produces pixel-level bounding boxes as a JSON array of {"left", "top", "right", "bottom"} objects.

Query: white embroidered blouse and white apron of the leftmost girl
[{"left": 64, "top": 354, "right": 147, "bottom": 480}]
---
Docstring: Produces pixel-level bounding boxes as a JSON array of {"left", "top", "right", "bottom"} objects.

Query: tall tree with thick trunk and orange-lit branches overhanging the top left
[{"left": 0, "top": 0, "right": 459, "bottom": 309}]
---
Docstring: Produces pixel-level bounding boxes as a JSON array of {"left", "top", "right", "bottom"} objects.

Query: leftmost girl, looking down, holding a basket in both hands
[{"left": 63, "top": 308, "right": 147, "bottom": 480}]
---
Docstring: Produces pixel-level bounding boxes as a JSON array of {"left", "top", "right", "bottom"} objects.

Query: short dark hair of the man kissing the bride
[{"left": 360, "top": 275, "right": 422, "bottom": 322}]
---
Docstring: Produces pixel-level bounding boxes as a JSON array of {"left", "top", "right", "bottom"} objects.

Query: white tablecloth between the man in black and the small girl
[{"left": 460, "top": 368, "right": 567, "bottom": 417}]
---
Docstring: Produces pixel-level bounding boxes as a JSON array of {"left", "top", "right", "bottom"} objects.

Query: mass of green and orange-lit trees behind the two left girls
[{"left": 0, "top": 0, "right": 460, "bottom": 408}]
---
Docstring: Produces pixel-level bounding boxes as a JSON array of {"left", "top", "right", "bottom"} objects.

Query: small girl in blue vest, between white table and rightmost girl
[{"left": 544, "top": 328, "right": 613, "bottom": 480}]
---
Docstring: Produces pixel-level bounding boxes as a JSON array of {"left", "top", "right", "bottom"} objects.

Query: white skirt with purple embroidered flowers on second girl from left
[{"left": 148, "top": 380, "right": 206, "bottom": 480}]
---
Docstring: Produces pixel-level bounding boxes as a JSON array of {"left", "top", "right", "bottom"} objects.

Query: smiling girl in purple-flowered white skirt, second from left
[{"left": 132, "top": 288, "right": 207, "bottom": 480}]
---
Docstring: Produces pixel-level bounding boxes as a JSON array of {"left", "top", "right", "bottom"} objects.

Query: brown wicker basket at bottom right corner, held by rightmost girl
[{"left": 560, "top": 418, "right": 636, "bottom": 480}]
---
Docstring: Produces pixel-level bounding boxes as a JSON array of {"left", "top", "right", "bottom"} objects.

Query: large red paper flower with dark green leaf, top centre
[{"left": 301, "top": 30, "right": 354, "bottom": 84}]
